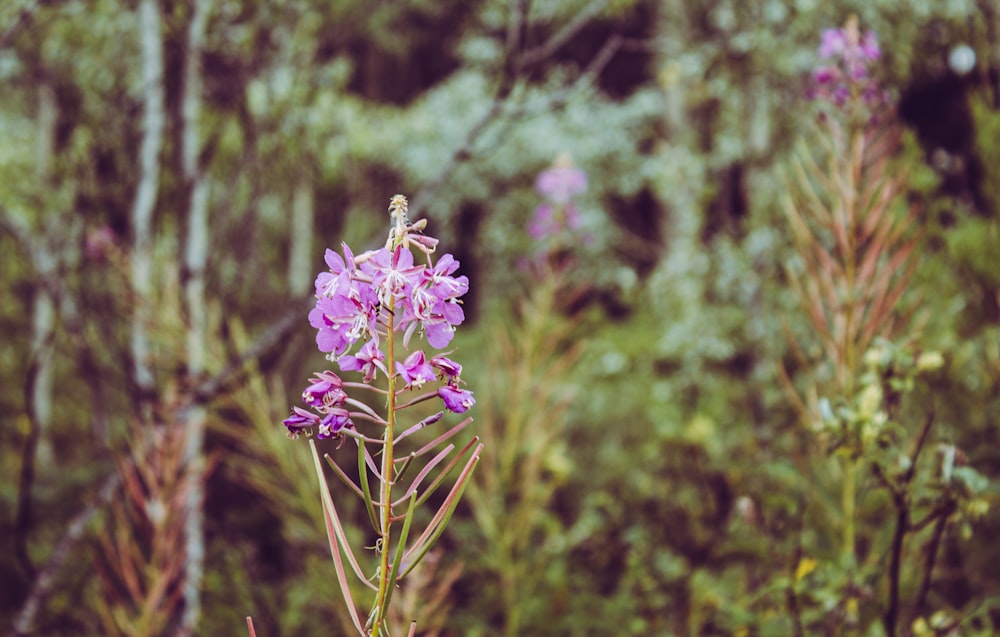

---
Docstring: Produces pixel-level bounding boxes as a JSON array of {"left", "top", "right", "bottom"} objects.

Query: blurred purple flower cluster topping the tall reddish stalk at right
[{"left": 808, "top": 16, "right": 886, "bottom": 108}]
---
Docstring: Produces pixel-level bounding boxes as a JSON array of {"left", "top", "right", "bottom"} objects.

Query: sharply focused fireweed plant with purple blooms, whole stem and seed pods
[{"left": 260, "top": 195, "right": 483, "bottom": 637}]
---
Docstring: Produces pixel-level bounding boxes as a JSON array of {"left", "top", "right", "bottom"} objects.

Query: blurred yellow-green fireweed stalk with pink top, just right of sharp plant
[{"left": 469, "top": 155, "right": 587, "bottom": 637}]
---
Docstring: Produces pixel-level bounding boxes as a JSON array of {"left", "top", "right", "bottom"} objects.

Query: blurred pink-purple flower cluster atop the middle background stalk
[{"left": 528, "top": 155, "right": 587, "bottom": 241}]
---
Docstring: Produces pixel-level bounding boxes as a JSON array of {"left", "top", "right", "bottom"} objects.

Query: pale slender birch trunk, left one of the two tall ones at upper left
[{"left": 131, "top": 0, "right": 166, "bottom": 422}]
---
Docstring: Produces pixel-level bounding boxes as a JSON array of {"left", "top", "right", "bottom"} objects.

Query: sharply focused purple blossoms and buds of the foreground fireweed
[{"left": 284, "top": 195, "right": 475, "bottom": 438}]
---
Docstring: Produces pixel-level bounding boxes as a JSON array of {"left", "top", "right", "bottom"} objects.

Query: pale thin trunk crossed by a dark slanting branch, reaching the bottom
[{"left": 178, "top": 0, "right": 211, "bottom": 636}]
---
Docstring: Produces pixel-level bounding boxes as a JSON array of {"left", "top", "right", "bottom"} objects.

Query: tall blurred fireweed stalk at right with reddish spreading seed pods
[{"left": 784, "top": 17, "right": 919, "bottom": 625}]
